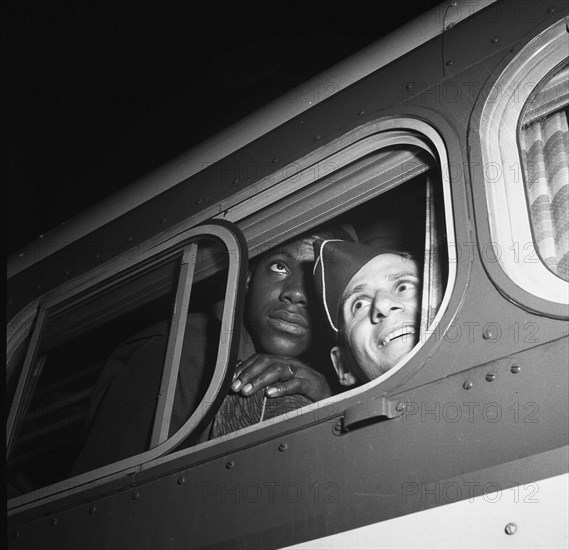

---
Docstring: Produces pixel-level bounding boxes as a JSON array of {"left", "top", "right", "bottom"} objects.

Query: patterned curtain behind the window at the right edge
[{"left": 519, "top": 65, "right": 569, "bottom": 281}]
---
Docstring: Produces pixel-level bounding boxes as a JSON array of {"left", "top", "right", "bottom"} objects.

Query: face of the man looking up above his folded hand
[{"left": 247, "top": 239, "right": 316, "bottom": 357}]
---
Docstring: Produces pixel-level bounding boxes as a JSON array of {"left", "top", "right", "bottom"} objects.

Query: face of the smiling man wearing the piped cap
[{"left": 340, "top": 254, "right": 420, "bottom": 380}]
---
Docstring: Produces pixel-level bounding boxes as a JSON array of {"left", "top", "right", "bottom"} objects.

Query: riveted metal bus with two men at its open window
[{"left": 6, "top": 0, "right": 569, "bottom": 550}]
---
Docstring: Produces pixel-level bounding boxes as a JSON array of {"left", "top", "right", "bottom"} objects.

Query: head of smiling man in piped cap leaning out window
[{"left": 314, "top": 240, "right": 421, "bottom": 386}]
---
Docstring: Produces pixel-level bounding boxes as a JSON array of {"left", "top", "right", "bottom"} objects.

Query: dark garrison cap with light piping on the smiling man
[{"left": 313, "top": 239, "right": 403, "bottom": 333}]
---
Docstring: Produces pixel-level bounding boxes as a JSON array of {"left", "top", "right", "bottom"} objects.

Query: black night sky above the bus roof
[{"left": 7, "top": 0, "right": 439, "bottom": 254}]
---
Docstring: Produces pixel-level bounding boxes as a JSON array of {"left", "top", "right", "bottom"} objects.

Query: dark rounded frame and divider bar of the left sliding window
[{"left": 6, "top": 220, "right": 248, "bottom": 509}]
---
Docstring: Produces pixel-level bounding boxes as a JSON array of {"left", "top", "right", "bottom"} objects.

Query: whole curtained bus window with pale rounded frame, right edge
[{"left": 469, "top": 20, "right": 569, "bottom": 308}]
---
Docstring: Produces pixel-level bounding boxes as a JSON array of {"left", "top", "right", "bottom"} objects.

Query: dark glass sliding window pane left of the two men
[{"left": 7, "top": 222, "right": 242, "bottom": 496}]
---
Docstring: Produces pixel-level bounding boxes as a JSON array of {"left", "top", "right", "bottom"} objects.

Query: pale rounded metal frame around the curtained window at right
[{"left": 469, "top": 18, "right": 569, "bottom": 310}]
